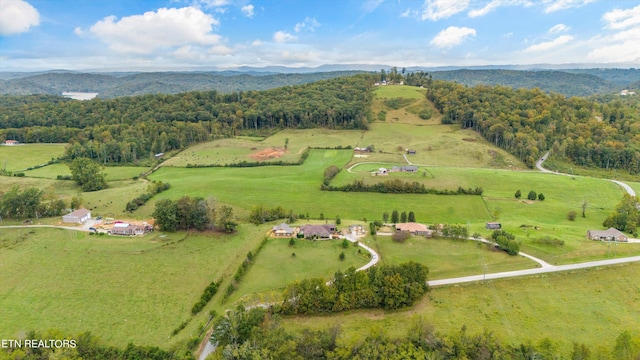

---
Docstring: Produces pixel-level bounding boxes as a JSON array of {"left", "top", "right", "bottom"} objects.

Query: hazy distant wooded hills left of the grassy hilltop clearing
[{"left": 0, "top": 71, "right": 361, "bottom": 99}]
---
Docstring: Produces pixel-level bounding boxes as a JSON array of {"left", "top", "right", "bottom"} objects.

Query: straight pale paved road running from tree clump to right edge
[{"left": 427, "top": 256, "right": 640, "bottom": 286}]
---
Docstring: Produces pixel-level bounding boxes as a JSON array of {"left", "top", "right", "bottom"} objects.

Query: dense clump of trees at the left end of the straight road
[{"left": 277, "top": 262, "right": 429, "bottom": 315}]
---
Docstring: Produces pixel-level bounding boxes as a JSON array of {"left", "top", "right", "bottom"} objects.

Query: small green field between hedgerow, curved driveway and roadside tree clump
[{"left": 229, "top": 236, "right": 369, "bottom": 304}]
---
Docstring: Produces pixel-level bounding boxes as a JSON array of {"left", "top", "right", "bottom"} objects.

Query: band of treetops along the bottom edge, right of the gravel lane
[{"left": 211, "top": 307, "right": 640, "bottom": 360}]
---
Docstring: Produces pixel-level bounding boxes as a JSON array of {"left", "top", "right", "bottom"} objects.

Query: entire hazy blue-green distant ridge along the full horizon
[{"left": 0, "top": 64, "right": 640, "bottom": 98}]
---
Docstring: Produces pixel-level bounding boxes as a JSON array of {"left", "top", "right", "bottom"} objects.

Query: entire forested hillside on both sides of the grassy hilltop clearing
[{"left": 0, "top": 72, "right": 640, "bottom": 174}]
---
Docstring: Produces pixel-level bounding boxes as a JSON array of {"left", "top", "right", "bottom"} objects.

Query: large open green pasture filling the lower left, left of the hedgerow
[{"left": 0, "top": 226, "right": 266, "bottom": 348}]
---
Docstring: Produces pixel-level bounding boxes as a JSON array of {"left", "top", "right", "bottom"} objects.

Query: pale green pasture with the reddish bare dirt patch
[{"left": 164, "top": 129, "right": 364, "bottom": 167}]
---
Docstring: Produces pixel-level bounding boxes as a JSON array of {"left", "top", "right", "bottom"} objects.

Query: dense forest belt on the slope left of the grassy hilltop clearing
[{"left": 0, "top": 74, "right": 373, "bottom": 164}]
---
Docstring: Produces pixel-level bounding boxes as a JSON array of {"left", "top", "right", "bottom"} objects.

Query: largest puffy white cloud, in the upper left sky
[{"left": 87, "top": 7, "right": 220, "bottom": 54}]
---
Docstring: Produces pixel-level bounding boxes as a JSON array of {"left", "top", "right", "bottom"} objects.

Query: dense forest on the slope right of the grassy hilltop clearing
[{"left": 427, "top": 81, "right": 640, "bottom": 174}]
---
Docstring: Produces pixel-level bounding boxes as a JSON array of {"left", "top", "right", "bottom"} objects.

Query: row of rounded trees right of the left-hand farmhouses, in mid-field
[{"left": 152, "top": 196, "right": 238, "bottom": 232}]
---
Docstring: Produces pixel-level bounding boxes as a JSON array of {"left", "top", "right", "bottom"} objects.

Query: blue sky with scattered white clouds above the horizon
[{"left": 0, "top": 0, "right": 640, "bottom": 71}]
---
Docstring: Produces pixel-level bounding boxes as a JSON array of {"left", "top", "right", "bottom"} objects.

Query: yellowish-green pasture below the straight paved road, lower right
[{"left": 283, "top": 263, "right": 640, "bottom": 356}]
